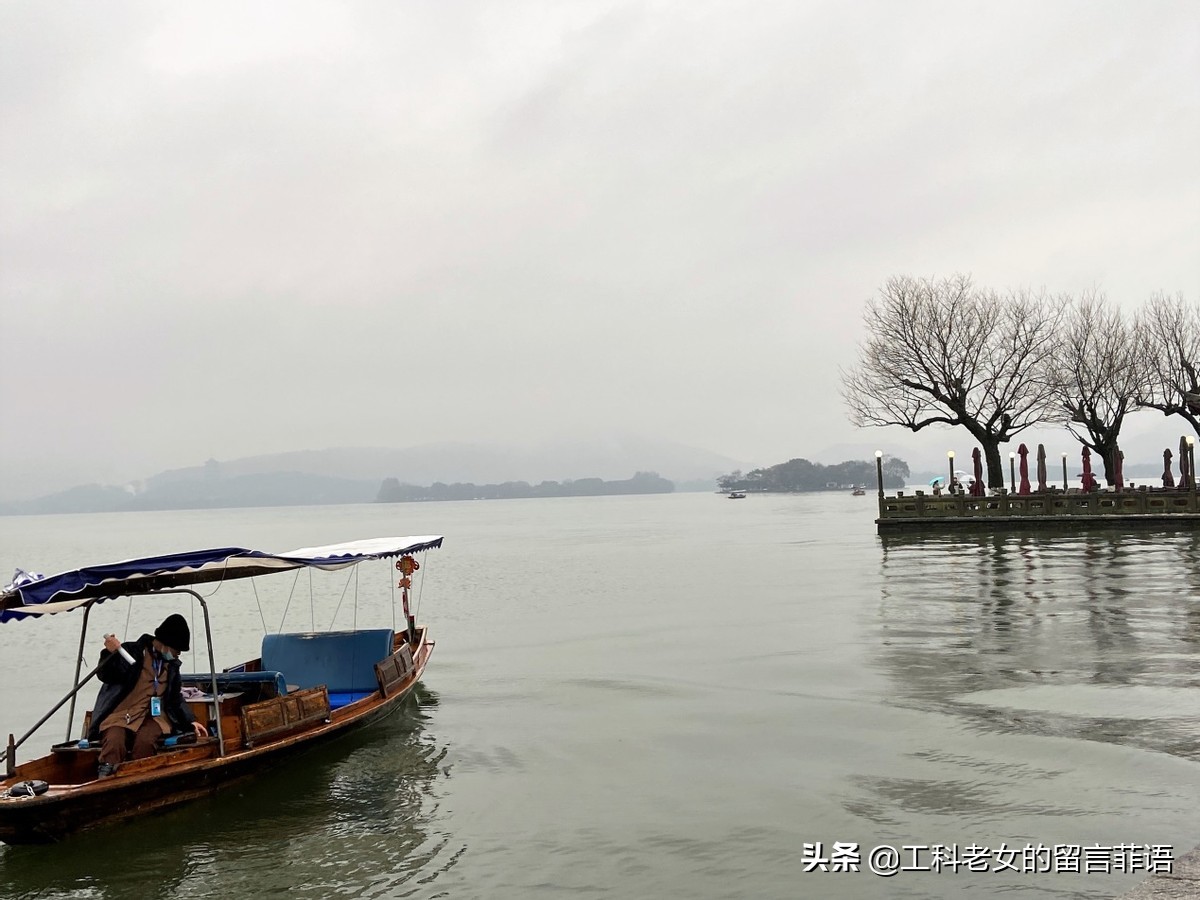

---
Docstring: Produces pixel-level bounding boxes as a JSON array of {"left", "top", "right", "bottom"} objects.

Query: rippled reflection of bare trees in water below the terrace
[{"left": 880, "top": 530, "right": 1200, "bottom": 758}]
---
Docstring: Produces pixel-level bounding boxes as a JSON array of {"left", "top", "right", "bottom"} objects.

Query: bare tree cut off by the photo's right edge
[{"left": 1138, "top": 294, "right": 1200, "bottom": 434}]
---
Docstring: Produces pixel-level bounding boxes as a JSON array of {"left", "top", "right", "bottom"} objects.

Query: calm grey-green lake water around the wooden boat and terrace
[{"left": 0, "top": 493, "right": 1200, "bottom": 900}]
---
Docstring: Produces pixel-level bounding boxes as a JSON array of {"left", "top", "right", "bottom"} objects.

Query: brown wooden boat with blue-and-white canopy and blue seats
[{"left": 0, "top": 535, "right": 442, "bottom": 844}]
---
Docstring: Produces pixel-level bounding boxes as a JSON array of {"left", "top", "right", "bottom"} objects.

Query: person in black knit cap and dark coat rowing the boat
[{"left": 88, "top": 613, "right": 209, "bottom": 778}]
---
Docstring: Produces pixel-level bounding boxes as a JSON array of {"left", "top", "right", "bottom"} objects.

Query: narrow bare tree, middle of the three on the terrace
[{"left": 1048, "top": 293, "right": 1147, "bottom": 485}]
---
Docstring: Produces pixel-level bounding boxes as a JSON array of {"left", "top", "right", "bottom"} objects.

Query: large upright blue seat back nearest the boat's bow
[{"left": 263, "top": 628, "right": 392, "bottom": 706}]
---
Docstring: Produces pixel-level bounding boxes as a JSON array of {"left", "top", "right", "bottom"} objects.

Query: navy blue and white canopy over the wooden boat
[{"left": 0, "top": 535, "right": 442, "bottom": 622}]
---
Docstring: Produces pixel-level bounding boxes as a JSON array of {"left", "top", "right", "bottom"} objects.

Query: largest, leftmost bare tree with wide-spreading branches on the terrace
[{"left": 841, "top": 275, "right": 1064, "bottom": 487}]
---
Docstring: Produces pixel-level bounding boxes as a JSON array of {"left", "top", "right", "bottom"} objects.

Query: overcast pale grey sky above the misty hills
[{"left": 0, "top": 0, "right": 1200, "bottom": 498}]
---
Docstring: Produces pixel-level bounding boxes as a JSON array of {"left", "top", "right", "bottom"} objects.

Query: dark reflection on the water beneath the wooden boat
[{"left": 0, "top": 685, "right": 462, "bottom": 900}]
